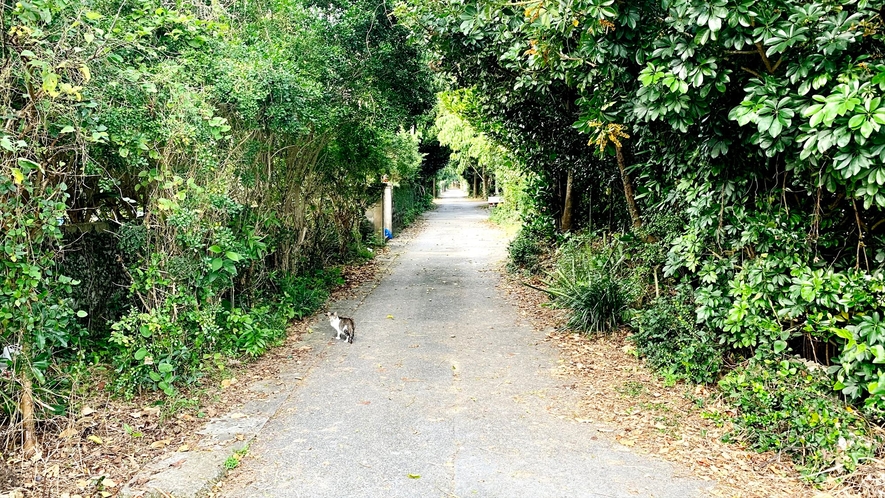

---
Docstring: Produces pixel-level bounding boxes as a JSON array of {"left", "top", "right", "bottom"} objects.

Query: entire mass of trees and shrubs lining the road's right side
[{"left": 398, "top": 0, "right": 885, "bottom": 482}]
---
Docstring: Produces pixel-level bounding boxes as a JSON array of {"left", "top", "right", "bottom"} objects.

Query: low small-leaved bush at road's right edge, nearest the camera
[{"left": 720, "top": 360, "right": 882, "bottom": 481}]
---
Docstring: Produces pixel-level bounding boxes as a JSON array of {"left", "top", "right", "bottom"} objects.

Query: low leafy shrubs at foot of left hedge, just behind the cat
[{"left": 103, "top": 269, "right": 343, "bottom": 398}]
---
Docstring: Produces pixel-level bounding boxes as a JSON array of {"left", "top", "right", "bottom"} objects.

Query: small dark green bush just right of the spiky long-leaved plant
[{"left": 631, "top": 290, "right": 722, "bottom": 384}]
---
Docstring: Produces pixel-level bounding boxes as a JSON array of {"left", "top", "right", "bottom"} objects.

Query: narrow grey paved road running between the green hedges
[{"left": 223, "top": 192, "right": 705, "bottom": 498}]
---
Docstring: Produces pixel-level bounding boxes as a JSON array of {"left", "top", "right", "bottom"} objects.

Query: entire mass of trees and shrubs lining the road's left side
[{"left": 0, "top": 0, "right": 433, "bottom": 464}]
